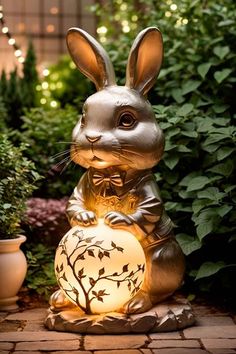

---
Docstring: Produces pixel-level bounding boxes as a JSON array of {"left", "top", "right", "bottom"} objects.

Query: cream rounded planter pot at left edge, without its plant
[{"left": 0, "top": 235, "right": 27, "bottom": 311}]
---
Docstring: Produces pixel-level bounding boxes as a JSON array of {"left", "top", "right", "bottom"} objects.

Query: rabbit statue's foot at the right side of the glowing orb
[{"left": 120, "top": 290, "right": 153, "bottom": 314}]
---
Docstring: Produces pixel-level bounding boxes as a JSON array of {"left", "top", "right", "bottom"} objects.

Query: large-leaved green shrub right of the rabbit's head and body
[{"left": 154, "top": 104, "right": 236, "bottom": 302}]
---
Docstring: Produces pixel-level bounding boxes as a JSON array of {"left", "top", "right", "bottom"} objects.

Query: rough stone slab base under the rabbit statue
[{"left": 45, "top": 299, "right": 195, "bottom": 334}]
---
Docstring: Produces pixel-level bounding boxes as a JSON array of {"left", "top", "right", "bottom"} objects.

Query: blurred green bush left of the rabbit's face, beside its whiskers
[{"left": 18, "top": 106, "right": 82, "bottom": 198}]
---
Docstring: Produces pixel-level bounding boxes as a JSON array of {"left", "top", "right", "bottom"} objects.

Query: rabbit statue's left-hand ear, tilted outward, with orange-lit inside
[{"left": 66, "top": 28, "right": 115, "bottom": 90}]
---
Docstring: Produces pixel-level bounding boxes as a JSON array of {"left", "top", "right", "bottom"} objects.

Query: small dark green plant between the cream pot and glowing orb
[{"left": 25, "top": 243, "right": 56, "bottom": 298}]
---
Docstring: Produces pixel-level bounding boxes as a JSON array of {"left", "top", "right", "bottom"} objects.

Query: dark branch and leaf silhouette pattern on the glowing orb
[{"left": 55, "top": 230, "right": 145, "bottom": 314}]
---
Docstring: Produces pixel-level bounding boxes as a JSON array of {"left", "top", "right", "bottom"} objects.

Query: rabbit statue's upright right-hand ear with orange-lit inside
[{"left": 126, "top": 27, "right": 163, "bottom": 95}]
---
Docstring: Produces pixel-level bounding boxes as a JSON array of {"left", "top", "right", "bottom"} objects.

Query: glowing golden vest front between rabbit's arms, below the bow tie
[{"left": 88, "top": 193, "right": 138, "bottom": 218}]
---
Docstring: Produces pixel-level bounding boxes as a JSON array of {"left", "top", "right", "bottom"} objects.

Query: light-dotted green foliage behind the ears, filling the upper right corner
[{"left": 94, "top": 0, "right": 236, "bottom": 113}]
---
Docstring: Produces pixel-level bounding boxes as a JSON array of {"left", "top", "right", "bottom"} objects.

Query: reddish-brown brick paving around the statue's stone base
[{"left": 0, "top": 306, "right": 236, "bottom": 354}]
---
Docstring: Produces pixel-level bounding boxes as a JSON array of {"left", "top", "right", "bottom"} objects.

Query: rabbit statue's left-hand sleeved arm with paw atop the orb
[{"left": 66, "top": 173, "right": 97, "bottom": 226}]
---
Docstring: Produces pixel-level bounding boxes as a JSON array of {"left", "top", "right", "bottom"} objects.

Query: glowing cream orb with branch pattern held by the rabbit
[{"left": 55, "top": 219, "right": 145, "bottom": 313}]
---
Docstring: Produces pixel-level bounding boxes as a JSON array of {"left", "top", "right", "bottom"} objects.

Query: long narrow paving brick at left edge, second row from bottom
[{"left": 0, "top": 331, "right": 81, "bottom": 342}]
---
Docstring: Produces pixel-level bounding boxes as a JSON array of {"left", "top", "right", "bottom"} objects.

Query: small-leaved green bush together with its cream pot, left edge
[{"left": 0, "top": 134, "right": 40, "bottom": 310}]
